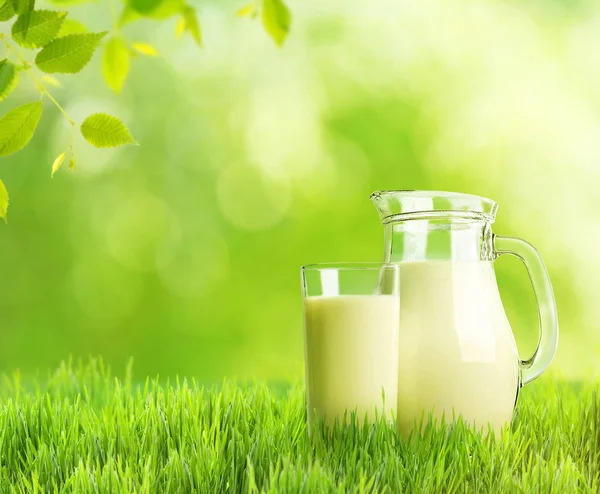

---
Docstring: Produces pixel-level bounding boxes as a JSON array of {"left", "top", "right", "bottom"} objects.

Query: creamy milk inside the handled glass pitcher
[{"left": 396, "top": 261, "right": 519, "bottom": 436}]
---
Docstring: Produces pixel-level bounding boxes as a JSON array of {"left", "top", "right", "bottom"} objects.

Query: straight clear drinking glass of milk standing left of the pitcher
[{"left": 302, "top": 263, "right": 400, "bottom": 430}]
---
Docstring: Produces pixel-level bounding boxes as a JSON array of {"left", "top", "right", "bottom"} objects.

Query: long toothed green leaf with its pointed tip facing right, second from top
[{"left": 35, "top": 32, "right": 106, "bottom": 74}]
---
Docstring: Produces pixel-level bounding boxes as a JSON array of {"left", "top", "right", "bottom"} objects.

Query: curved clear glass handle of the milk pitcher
[{"left": 494, "top": 235, "right": 558, "bottom": 384}]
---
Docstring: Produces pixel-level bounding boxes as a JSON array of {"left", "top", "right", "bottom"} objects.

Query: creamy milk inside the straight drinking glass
[{"left": 304, "top": 295, "right": 399, "bottom": 427}]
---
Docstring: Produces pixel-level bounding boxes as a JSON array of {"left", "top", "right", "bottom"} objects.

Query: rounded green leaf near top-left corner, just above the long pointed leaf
[{"left": 11, "top": 10, "right": 67, "bottom": 48}]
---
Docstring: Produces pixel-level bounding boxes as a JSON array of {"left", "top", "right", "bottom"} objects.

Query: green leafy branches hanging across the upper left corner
[{"left": 0, "top": 0, "right": 291, "bottom": 221}]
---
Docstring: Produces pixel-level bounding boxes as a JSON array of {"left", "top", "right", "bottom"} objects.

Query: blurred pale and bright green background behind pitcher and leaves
[{"left": 0, "top": 0, "right": 600, "bottom": 380}]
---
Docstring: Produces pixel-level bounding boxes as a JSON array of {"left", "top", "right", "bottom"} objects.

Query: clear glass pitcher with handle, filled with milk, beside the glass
[{"left": 370, "top": 190, "right": 558, "bottom": 435}]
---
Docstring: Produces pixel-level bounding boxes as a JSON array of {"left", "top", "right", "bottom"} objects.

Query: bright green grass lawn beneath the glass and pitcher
[{"left": 0, "top": 360, "right": 600, "bottom": 494}]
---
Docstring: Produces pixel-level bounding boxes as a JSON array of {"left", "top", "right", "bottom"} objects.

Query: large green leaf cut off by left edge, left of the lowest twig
[{"left": 0, "top": 101, "right": 43, "bottom": 156}]
